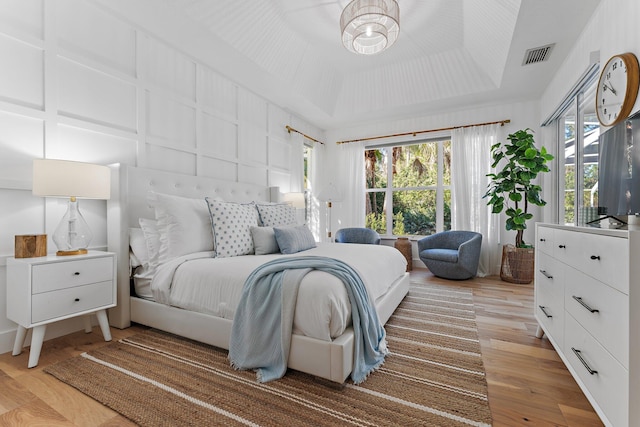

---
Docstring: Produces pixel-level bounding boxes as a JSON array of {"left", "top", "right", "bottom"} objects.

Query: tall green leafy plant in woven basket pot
[{"left": 484, "top": 128, "right": 553, "bottom": 283}]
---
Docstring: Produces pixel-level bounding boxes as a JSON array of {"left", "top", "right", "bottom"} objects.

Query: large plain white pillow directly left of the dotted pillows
[{"left": 147, "top": 191, "right": 213, "bottom": 264}]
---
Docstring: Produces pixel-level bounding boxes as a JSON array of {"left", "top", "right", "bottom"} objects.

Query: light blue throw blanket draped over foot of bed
[{"left": 229, "top": 256, "right": 388, "bottom": 384}]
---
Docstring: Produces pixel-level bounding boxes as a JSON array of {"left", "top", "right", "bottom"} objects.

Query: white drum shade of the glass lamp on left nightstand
[{"left": 33, "top": 159, "right": 111, "bottom": 200}]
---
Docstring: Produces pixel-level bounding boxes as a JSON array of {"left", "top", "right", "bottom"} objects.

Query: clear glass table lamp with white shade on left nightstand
[{"left": 33, "top": 159, "right": 111, "bottom": 255}]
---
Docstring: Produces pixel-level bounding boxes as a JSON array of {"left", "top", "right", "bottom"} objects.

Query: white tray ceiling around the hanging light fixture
[{"left": 97, "top": 0, "right": 599, "bottom": 129}]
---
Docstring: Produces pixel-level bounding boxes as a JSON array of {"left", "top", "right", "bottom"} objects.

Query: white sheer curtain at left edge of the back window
[{"left": 338, "top": 141, "right": 365, "bottom": 227}]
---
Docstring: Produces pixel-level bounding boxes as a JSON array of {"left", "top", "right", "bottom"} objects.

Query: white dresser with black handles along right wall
[{"left": 535, "top": 224, "right": 640, "bottom": 427}]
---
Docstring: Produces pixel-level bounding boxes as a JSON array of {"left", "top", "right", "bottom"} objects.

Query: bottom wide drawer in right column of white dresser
[{"left": 564, "top": 315, "right": 637, "bottom": 427}]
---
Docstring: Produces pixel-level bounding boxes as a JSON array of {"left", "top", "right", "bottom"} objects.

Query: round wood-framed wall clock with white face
[{"left": 596, "top": 52, "right": 640, "bottom": 126}]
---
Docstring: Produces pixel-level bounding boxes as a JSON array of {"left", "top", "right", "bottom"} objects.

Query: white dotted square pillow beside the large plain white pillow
[{"left": 206, "top": 198, "right": 258, "bottom": 258}]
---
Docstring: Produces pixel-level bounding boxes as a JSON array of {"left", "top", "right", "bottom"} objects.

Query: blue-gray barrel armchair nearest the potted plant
[{"left": 418, "top": 231, "right": 482, "bottom": 280}]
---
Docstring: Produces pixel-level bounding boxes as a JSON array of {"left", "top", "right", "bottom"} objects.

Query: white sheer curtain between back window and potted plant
[{"left": 451, "top": 124, "right": 501, "bottom": 276}]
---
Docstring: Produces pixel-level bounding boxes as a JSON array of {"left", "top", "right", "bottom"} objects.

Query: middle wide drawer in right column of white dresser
[{"left": 565, "top": 267, "right": 629, "bottom": 368}]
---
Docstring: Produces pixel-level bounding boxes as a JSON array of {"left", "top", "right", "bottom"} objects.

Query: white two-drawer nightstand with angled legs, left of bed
[{"left": 7, "top": 251, "right": 116, "bottom": 368}]
